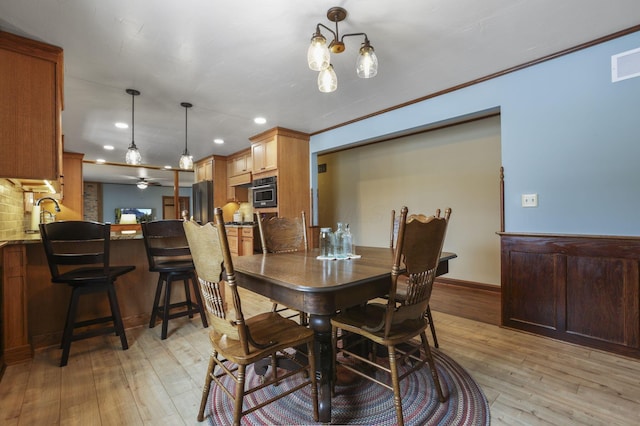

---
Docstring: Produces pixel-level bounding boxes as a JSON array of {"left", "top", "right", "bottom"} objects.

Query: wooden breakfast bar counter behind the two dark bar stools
[{"left": 0, "top": 228, "right": 190, "bottom": 369}]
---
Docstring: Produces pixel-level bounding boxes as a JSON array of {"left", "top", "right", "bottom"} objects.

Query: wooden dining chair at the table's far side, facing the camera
[{"left": 256, "top": 211, "right": 309, "bottom": 325}]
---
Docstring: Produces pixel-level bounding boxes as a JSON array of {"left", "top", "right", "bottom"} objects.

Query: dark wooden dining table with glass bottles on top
[{"left": 233, "top": 246, "right": 457, "bottom": 423}]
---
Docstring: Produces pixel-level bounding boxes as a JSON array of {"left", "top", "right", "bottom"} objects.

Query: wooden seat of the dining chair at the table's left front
[{"left": 209, "top": 312, "right": 313, "bottom": 365}]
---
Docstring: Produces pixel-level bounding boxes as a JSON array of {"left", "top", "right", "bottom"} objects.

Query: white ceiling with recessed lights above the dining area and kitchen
[{"left": 0, "top": 0, "right": 640, "bottom": 186}]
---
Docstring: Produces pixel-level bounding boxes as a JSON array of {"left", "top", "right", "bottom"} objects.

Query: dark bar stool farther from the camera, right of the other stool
[{"left": 142, "top": 219, "right": 209, "bottom": 340}]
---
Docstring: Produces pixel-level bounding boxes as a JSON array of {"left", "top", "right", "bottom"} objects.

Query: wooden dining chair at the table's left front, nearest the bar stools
[{"left": 184, "top": 208, "right": 318, "bottom": 425}]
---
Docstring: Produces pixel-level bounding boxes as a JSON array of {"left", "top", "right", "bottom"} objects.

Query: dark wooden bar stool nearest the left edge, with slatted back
[{"left": 40, "top": 221, "right": 135, "bottom": 367}]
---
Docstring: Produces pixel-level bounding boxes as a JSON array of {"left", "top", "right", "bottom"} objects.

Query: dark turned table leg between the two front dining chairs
[{"left": 309, "top": 315, "right": 333, "bottom": 423}]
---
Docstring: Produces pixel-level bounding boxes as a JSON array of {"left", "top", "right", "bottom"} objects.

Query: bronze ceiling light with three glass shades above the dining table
[{"left": 307, "top": 7, "right": 378, "bottom": 93}]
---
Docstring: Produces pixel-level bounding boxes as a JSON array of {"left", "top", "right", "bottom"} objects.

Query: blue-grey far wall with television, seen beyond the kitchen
[{"left": 102, "top": 183, "right": 191, "bottom": 223}]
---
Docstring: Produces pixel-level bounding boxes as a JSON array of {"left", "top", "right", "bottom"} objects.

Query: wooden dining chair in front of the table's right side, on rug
[{"left": 331, "top": 207, "right": 449, "bottom": 425}]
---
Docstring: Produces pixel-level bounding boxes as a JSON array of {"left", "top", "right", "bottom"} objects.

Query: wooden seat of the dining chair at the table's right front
[{"left": 331, "top": 303, "right": 429, "bottom": 346}]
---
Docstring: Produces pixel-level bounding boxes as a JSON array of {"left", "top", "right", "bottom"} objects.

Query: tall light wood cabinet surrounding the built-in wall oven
[{"left": 249, "top": 127, "right": 312, "bottom": 218}]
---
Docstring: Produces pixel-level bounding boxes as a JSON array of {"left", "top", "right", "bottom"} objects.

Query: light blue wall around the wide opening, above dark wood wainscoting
[{"left": 310, "top": 33, "right": 640, "bottom": 236}]
